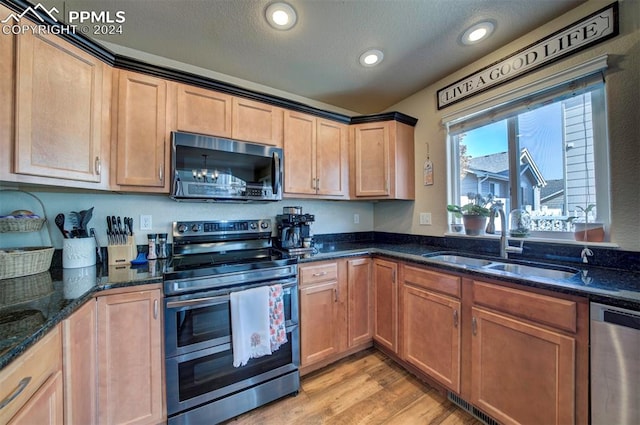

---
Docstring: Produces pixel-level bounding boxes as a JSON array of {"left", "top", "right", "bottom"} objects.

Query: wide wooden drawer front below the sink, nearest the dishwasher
[{"left": 473, "top": 281, "right": 578, "bottom": 333}]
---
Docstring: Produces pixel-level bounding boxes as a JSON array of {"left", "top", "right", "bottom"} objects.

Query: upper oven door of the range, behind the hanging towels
[{"left": 164, "top": 278, "right": 298, "bottom": 358}]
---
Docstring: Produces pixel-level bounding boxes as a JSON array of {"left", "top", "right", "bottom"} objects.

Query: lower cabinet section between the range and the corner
[{"left": 299, "top": 257, "right": 373, "bottom": 374}]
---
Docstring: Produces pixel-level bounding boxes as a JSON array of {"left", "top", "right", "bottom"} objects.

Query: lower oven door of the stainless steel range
[{"left": 166, "top": 325, "right": 300, "bottom": 415}]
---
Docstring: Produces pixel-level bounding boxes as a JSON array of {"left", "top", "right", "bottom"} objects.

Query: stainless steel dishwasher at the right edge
[{"left": 591, "top": 303, "right": 640, "bottom": 425}]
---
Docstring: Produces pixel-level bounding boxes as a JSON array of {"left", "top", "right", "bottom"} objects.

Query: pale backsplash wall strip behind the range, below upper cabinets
[{"left": 0, "top": 187, "right": 373, "bottom": 248}]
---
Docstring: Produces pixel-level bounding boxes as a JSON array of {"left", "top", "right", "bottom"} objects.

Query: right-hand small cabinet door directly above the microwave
[{"left": 231, "top": 97, "right": 283, "bottom": 147}]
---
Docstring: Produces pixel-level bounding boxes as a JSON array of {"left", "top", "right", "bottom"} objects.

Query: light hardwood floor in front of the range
[{"left": 227, "top": 349, "right": 482, "bottom": 425}]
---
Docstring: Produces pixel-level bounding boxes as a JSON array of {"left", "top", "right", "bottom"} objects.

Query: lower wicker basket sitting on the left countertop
[{"left": 0, "top": 247, "right": 54, "bottom": 279}]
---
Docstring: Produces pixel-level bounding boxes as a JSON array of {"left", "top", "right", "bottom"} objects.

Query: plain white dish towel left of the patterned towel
[{"left": 230, "top": 286, "right": 271, "bottom": 367}]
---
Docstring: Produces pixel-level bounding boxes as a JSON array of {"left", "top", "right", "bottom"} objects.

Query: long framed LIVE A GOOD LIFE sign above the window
[{"left": 437, "top": 2, "right": 619, "bottom": 109}]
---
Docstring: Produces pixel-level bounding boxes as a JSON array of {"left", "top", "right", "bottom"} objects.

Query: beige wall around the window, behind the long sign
[{"left": 374, "top": 0, "right": 640, "bottom": 251}]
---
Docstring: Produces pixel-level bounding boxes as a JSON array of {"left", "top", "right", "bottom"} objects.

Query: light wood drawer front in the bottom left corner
[{"left": 0, "top": 326, "right": 62, "bottom": 424}]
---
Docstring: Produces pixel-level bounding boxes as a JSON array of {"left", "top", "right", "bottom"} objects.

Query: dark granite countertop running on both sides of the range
[{"left": 0, "top": 241, "right": 640, "bottom": 369}]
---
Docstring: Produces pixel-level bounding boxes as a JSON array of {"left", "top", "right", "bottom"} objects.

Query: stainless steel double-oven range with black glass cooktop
[{"left": 164, "top": 220, "right": 300, "bottom": 425}]
